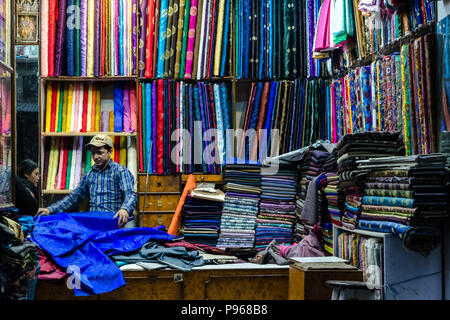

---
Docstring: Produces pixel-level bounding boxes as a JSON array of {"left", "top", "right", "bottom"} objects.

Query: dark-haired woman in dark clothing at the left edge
[{"left": 15, "top": 159, "right": 40, "bottom": 216}]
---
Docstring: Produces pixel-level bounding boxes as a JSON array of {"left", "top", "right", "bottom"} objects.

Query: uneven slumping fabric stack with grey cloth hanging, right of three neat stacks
[{"left": 295, "top": 149, "right": 330, "bottom": 241}]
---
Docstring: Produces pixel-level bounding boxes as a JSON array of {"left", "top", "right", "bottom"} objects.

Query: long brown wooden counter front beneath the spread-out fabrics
[{"left": 35, "top": 263, "right": 289, "bottom": 300}]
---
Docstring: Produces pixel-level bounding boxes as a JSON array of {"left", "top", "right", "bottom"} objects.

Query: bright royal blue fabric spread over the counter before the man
[{"left": 31, "top": 211, "right": 175, "bottom": 296}]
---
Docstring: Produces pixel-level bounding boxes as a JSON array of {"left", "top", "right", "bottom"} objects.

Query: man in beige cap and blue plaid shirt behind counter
[{"left": 36, "top": 134, "right": 137, "bottom": 228}]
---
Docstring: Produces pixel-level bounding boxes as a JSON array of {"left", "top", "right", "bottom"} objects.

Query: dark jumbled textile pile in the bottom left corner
[{"left": 0, "top": 215, "right": 39, "bottom": 300}]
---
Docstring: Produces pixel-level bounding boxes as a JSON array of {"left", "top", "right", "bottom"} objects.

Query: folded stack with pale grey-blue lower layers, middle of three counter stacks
[{"left": 217, "top": 164, "right": 261, "bottom": 249}]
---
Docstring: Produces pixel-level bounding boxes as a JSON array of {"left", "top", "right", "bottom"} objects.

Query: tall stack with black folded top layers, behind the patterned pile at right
[{"left": 336, "top": 131, "right": 405, "bottom": 229}]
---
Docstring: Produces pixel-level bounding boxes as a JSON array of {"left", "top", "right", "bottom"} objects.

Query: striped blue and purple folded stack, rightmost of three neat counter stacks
[{"left": 255, "top": 167, "right": 297, "bottom": 249}]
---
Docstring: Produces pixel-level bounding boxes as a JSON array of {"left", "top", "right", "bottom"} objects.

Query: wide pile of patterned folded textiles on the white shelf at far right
[{"left": 357, "top": 154, "right": 448, "bottom": 226}]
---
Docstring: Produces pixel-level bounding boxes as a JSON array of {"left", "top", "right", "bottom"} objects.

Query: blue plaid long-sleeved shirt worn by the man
[{"left": 48, "top": 160, "right": 137, "bottom": 216}]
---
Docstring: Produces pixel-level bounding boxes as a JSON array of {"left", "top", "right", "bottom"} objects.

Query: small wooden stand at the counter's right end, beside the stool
[{"left": 289, "top": 266, "right": 363, "bottom": 300}]
